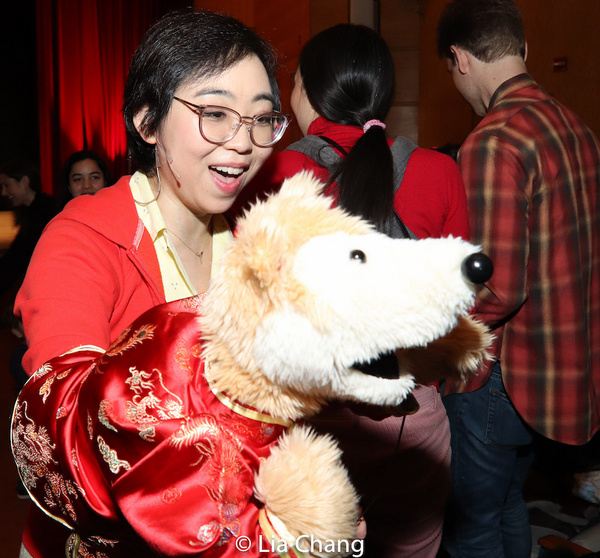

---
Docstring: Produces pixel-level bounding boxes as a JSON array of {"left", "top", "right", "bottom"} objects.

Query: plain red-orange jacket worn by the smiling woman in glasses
[{"left": 15, "top": 176, "right": 165, "bottom": 374}]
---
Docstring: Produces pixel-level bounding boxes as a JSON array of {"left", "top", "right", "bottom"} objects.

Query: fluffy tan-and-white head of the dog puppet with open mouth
[{"left": 202, "top": 173, "right": 490, "bottom": 419}]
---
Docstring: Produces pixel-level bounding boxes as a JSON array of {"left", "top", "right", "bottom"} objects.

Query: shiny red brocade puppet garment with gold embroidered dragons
[{"left": 12, "top": 297, "right": 285, "bottom": 558}]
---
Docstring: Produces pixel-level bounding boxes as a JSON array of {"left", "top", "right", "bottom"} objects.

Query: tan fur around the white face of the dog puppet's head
[{"left": 202, "top": 173, "right": 371, "bottom": 420}]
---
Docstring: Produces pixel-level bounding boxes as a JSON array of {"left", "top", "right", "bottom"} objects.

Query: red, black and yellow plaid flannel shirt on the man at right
[{"left": 451, "top": 74, "right": 600, "bottom": 444}]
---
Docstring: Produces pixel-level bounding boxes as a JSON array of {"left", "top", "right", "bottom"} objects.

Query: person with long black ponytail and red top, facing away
[{"left": 238, "top": 24, "right": 468, "bottom": 558}]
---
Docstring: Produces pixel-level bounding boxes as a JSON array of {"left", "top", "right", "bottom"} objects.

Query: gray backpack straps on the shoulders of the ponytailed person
[{"left": 285, "top": 135, "right": 418, "bottom": 239}]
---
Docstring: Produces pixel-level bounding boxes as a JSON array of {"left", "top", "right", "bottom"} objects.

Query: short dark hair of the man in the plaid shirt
[{"left": 437, "top": 0, "right": 525, "bottom": 63}]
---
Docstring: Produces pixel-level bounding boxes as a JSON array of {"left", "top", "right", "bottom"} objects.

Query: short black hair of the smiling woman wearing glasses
[{"left": 123, "top": 11, "right": 281, "bottom": 175}]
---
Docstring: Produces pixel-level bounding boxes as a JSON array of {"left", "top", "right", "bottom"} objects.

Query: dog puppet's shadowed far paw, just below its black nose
[{"left": 396, "top": 316, "right": 492, "bottom": 390}]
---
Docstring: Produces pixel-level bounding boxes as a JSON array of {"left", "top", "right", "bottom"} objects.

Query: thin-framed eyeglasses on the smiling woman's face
[{"left": 173, "top": 97, "right": 291, "bottom": 147}]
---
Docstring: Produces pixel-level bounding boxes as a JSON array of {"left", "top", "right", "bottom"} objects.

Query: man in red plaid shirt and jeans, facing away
[{"left": 438, "top": 0, "right": 600, "bottom": 558}]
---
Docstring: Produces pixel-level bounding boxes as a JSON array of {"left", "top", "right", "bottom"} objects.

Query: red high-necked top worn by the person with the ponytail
[{"left": 236, "top": 117, "right": 469, "bottom": 240}]
